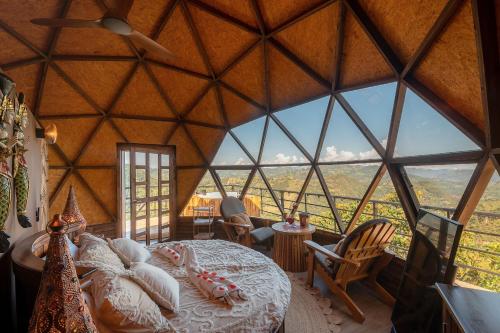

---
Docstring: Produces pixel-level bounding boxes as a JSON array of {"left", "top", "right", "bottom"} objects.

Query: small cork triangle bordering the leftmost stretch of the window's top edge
[{"left": 221, "top": 88, "right": 264, "bottom": 127}]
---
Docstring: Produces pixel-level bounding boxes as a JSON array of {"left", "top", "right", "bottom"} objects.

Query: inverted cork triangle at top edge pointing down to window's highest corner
[{"left": 360, "top": 0, "right": 448, "bottom": 64}]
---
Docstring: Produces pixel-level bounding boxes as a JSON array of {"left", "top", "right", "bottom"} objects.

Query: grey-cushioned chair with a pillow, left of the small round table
[{"left": 220, "top": 197, "right": 274, "bottom": 249}]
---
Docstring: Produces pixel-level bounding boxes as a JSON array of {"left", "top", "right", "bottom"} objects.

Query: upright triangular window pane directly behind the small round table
[{"left": 298, "top": 172, "right": 339, "bottom": 233}]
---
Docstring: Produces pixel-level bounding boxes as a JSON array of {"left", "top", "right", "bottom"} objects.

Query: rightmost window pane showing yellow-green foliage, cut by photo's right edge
[{"left": 455, "top": 172, "right": 500, "bottom": 292}]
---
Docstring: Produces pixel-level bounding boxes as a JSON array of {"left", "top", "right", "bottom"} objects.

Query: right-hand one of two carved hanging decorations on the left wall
[{"left": 12, "top": 93, "right": 31, "bottom": 228}]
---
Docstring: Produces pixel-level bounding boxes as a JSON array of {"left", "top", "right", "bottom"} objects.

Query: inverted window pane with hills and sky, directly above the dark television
[{"left": 405, "top": 164, "right": 475, "bottom": 210}]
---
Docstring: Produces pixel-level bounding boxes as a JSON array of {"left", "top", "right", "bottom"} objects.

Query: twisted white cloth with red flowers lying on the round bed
[{"left": 157, "top": 244, "right": 248, "bottom": 305}]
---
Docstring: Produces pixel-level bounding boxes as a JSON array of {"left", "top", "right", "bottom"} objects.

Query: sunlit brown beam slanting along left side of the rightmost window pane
[{"left": 452, "top": 154, "right": 495, "bottom": 224}]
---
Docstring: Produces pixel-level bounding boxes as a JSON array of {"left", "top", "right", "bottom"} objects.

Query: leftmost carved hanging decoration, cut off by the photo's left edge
[{"left": 0, "top": 74, "right": 15, "bottom": 252}]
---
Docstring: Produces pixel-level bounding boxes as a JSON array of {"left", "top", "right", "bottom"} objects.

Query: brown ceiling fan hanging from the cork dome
[{"left": 31, "top": 0, "right": 174, "bottom": 58}]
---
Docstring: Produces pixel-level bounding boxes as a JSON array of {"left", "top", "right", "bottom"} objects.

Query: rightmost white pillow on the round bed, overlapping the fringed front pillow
[{"left": 129, "top": 262, "right": 179, "bottom": 312}]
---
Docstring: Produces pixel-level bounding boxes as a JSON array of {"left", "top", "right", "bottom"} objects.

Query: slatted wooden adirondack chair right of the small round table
[{"left": 304, "top": 219, "right": 395, "bottom": 322}]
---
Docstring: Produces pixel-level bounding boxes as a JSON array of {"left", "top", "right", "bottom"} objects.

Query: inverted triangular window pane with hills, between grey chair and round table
[{"left": 262, "top": 166, "right": 310, "bottom": 213}]
